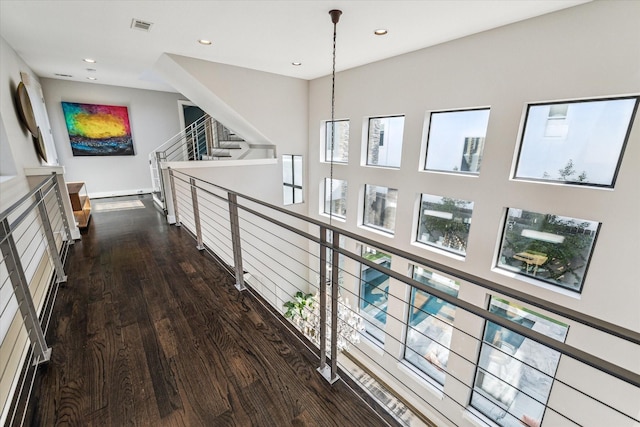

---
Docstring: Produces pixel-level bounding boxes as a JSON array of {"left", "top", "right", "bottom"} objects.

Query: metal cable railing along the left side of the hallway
[{"left": 0, "top": 174, "right": 73, "bottom": 424}]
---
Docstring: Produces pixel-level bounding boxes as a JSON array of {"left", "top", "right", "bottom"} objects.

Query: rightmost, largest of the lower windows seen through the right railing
[{"left": 471, "top": 297, "right": 568, "bottom": 427}]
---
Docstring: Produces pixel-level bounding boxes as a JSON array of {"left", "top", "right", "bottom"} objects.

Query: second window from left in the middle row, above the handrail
[{"left": 363, "top": 184, "right": 398, "bottom": 234}]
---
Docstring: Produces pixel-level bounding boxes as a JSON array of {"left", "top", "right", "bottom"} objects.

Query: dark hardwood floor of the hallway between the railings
[{"left": 25, "top": 196, "right": 391, "bottom": 427}]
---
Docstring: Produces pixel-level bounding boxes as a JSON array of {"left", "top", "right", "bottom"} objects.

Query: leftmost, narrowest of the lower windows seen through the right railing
[{"left": 360, "top": 246, "right": 391, "bottom": 343}]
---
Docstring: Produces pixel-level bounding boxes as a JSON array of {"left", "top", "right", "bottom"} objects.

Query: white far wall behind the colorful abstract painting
[{"left": 41, "top": 78, "right": 184, "bottom": 197}]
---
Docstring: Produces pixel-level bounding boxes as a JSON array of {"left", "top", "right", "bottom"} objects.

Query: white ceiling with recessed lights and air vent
[{"left": 0, "top": 0, "right": 588, "bottom": 90}]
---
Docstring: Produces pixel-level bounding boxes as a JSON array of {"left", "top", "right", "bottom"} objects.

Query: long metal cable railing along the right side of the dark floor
[{"left": 169, "top": 170, "right": 640, "bottom": 427}]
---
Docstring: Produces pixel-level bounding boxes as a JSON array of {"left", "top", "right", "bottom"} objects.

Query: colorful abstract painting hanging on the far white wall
[{"left": 62, "top": 102, "right": 135, "bottom": 156}]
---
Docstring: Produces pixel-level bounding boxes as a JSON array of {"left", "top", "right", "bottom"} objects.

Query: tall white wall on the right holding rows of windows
[{"left": 307, "top": 2, "right": 640, "bottom": 425}]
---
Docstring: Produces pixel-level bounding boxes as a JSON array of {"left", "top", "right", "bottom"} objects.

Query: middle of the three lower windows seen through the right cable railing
[{"left": 404, "top": 265, "right": 460, "bottom": 385}]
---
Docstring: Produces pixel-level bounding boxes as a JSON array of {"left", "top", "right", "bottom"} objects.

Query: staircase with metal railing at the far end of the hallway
[{"left": 149, "top": 114, "right": 276, "bottom": 209}]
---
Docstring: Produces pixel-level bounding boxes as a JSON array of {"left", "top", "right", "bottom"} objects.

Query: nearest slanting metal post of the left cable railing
[{"left": 0, "top": 218, "right": 51, "bottom": 365}]
